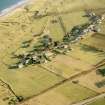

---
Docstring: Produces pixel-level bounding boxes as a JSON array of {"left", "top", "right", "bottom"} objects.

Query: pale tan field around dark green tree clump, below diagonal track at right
[{"left": 72, "top": 70, "right": 105, "bottom": 93}]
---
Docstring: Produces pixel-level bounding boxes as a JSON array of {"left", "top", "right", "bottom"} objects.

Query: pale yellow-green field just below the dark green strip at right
[{"left": 68, "top": 44, "right": 105, "bottom": 65}]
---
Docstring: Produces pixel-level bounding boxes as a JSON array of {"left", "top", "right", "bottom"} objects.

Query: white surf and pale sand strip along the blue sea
[{"left": 0, "top": 0, "right": 31, "bottom": 18}]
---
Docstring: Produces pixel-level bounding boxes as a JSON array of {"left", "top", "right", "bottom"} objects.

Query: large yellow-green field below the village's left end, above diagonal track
[{"left": 0, "top": 64, "right": 63, "bottom": 98}]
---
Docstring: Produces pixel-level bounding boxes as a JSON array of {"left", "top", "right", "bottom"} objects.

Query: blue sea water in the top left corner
[{"left": 0, "top": 0, "right": 22, "bottom": 11}]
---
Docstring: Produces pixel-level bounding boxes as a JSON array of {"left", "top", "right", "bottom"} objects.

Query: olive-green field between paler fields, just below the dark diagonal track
[{"left": 55, "top": 82, "right": 96, "bottom": 102}]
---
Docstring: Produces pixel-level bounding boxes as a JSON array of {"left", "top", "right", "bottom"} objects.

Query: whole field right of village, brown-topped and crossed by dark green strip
[{"left": 66, "top": 33, "right": 105, "bottom": 65}]
